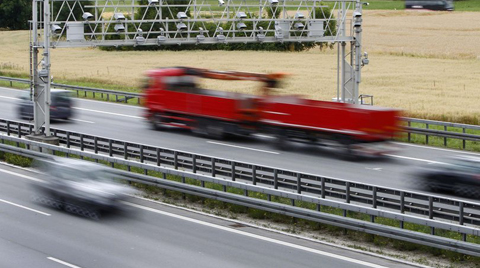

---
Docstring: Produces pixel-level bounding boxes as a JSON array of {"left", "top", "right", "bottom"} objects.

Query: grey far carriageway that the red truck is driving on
[{"left": 0, "top": 88, "right": 478, "bottom": 195}]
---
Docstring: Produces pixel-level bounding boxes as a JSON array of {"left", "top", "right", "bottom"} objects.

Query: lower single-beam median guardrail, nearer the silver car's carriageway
[{"left": 0, "top": 135, "right": 480, "bottom": 256}]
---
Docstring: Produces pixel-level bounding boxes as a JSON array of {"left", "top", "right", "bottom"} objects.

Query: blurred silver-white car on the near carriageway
[{"left": 33, "top": 158, "right": 137, "bottom": 219}]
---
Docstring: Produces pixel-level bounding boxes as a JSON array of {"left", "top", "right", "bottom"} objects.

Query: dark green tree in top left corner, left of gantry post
[{"left": 0, "top": 0, "right": 32, "bottom": 30}]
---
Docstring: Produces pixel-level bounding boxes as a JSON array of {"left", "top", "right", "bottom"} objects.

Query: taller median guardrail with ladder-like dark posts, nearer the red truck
[{"left": 0, "top": 119, "right": 480, "bottom": 241}]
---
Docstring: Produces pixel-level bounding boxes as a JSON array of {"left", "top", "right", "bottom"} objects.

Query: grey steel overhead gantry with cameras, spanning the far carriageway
[{"left": 30, "top": 0, "right": 368, "bottom": 136}]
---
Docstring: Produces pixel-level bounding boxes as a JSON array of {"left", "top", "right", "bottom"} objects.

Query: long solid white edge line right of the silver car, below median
[{"left": 124, "top": 202, "right": 385, "bottom": 268}]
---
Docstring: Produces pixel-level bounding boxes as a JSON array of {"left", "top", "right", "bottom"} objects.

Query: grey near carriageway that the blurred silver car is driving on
[{"left": 0, "top": 164, "right": 411, "bottom": 268}]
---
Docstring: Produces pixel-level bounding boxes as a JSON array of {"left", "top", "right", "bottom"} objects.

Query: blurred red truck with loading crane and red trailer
[{"left": 144, "top": 67, "right": 400, "bottom": 155}]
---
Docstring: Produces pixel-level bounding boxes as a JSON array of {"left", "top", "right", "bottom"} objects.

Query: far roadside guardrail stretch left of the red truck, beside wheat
[{"left": 0, "top": 76, "right": 142, "bottom": 104}]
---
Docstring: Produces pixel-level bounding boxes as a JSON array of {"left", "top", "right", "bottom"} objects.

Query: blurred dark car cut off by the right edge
[{"left": 417, "top": 156, "right": 480, "bottom": 197}]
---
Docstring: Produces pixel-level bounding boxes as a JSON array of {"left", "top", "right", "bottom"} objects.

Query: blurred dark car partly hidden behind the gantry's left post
[{"left": 17, "top": 89, "right": 73, "bottom": 120}]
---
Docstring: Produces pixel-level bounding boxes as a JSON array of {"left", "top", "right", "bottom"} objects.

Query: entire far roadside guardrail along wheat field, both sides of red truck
[{"left": 0, "top": 76, "right": 480, "bottom": 149}]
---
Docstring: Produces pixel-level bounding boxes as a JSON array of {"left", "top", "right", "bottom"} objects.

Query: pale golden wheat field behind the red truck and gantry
[{"left": 0, "top": 11, "right": 480, "bottom": 122}]
